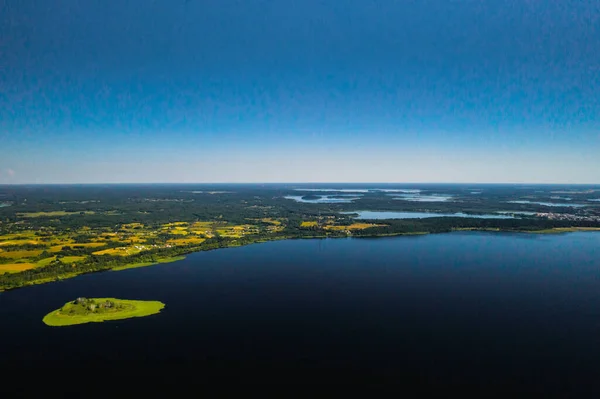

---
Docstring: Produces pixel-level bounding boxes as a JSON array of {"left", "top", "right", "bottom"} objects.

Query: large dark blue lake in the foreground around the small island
[{"left": 0, "top": 233, "right": 600, "bottom": 394}]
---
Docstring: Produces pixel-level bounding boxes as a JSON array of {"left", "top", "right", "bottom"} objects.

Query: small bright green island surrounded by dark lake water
[{"left": 43, "top": 297, "right": 165, "bottom": 327}]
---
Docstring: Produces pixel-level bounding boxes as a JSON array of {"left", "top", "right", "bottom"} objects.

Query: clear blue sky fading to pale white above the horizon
[{"left": 0, "top": 0, "right": 600, "bottom": 183}]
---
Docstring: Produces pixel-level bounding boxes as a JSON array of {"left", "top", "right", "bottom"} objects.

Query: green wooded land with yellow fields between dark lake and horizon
[{"left": 0, "top": 186, "right": 600, "bottom": 291}]
